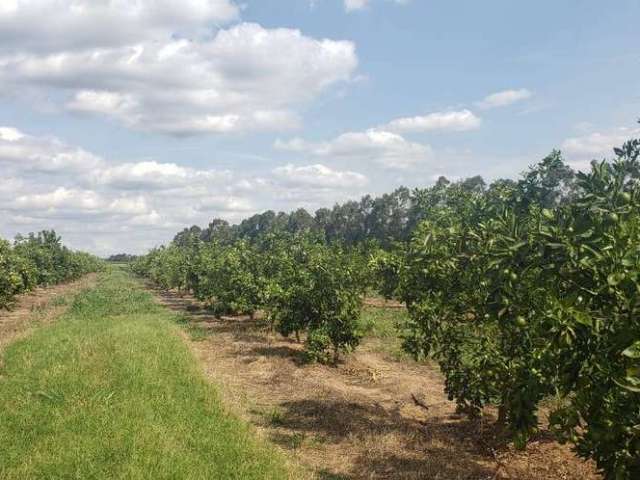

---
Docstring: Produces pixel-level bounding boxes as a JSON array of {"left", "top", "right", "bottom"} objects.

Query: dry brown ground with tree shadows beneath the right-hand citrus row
[{"left": 155, "top": 284, "right": 600, "bottom": 480}]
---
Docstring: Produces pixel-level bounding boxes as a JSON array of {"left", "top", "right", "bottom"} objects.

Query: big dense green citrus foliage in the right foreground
[{"left": 402, "top": 137, "right": 640, "bottom": 479}]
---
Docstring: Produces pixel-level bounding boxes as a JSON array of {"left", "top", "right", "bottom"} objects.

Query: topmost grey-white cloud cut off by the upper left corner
[{"left": 0, "top": 0, "right": 239, "bottom": 52}]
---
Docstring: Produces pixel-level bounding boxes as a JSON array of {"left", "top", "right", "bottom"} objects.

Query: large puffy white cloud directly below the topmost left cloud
[{"left": 0, "top": 19, "right": 358, "bottom": 135}]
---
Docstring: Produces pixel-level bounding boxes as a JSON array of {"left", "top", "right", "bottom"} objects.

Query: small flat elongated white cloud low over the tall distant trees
[{"left": 273, "top": 164, "right": 367, "bottom": 188}]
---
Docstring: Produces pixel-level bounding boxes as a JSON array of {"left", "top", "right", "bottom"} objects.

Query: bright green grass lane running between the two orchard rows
[{"left": 0, "top": 268, "right": 288, "bottom": 479}]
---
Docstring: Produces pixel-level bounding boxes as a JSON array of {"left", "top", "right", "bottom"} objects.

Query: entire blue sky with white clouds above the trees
[{"left": 0, "top": 0, "right": 640, "bottom": 255}]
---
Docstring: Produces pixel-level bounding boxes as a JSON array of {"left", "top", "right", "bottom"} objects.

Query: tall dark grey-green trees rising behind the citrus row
[{"left": 173, "top": 151, "right": 577, "bottom": 248}]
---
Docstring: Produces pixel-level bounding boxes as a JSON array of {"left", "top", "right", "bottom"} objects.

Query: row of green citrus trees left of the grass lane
[{"left": 0, "top": 230, "right": 101, "bottom": 310}]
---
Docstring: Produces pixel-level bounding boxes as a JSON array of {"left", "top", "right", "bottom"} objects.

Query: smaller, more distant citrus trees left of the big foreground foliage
[{"left": 134, "top": 234, "right": 367, "bottom": 360}]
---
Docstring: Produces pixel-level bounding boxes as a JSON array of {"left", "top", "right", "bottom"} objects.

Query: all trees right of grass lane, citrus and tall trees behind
[{"left": 135, "top": 133, "right": 640, "bottom": 480}]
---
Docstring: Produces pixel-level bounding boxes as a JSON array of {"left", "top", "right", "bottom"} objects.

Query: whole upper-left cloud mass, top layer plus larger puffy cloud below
[{"left": 0, "top": 0, "right": 358, "bottom": 135}]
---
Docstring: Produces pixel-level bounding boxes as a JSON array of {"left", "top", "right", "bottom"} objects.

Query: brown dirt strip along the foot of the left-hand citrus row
[{"left": 0, "top": 273, "right": 97, "bottom": 351}]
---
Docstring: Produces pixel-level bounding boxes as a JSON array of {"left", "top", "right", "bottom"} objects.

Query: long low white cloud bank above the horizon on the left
[{"left": 0, "top": 127, "right": 367, "bottom": 254}]
